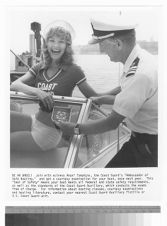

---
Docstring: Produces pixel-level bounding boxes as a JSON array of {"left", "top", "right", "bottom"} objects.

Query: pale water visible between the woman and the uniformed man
[{"left": 73, "top": 55, "right": 122, "bottom": 97}]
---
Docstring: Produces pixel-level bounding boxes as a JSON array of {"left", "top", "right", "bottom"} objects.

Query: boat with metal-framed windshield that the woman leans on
[{"left": 10, "top": 91, "right": 130, "bottom": 168}]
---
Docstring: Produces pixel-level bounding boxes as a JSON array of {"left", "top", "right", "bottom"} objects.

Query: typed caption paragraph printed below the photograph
[{"left": 12, "top": 173, "right": 153, "bottom": 198}]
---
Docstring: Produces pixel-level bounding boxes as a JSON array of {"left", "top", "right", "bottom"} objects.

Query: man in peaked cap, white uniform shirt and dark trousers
[{"left": 59, "top": 17, "right": 158, "bottom": 167}]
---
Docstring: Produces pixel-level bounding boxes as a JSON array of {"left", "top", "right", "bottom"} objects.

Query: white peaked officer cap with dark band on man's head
[{"left": 89, "top": 19, "right": 137, "bottom": 44}]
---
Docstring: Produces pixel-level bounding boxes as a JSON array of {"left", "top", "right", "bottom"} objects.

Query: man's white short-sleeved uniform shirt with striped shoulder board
[{"left": 113, "top": 45, "right": 158, "bottom": 134}]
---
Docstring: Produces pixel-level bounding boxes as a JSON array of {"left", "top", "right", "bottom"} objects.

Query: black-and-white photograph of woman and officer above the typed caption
[{"left": 8, "top": 6, "right": 161, "bottom": 168}]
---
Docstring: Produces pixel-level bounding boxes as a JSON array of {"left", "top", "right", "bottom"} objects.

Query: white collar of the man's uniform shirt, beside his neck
[{"left": 123, "top": 44, "right": 140, "bottom": 73}]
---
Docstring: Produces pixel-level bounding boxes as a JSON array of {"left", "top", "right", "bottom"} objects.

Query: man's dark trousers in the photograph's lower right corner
[{"left": 106, "top": 132, "right": 158, "bottom": 168}]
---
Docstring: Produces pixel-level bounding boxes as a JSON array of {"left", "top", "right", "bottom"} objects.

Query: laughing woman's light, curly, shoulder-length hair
[{"left": 42, "top": 27, "right": 74, "bottom": 68}]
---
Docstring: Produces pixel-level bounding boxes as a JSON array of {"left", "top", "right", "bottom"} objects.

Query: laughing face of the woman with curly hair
[{"left": 47, "top": 35, "right": 67, "bottom": 61}]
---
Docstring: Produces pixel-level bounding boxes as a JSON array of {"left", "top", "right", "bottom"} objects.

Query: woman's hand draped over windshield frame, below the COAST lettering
[{"left": 36, "top": 88, "right": 54, "bottom": 112}]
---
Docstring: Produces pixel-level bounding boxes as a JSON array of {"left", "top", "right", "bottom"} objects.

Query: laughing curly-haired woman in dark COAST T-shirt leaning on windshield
[{"left": 11, "top": 22, "right": 97, "bottom": 151}]
